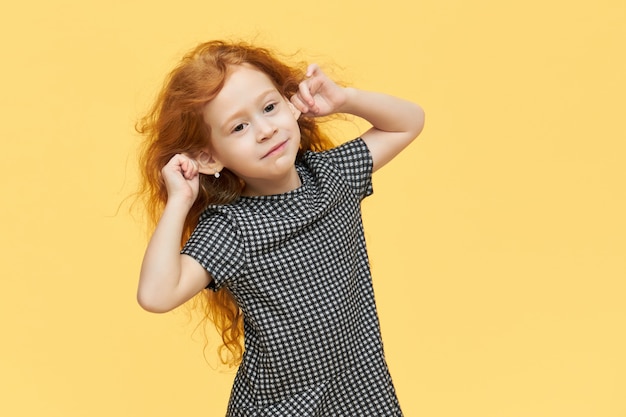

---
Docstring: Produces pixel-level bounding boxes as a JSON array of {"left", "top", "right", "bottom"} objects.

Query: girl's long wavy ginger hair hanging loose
[{"left": 136, "top": 41, "right": 333, "bottom": 366}]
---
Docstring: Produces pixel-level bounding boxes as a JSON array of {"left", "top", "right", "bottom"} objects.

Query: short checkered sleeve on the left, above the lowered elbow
[{"left": 181, "top": 211, "right": 245, "bottom": 291}]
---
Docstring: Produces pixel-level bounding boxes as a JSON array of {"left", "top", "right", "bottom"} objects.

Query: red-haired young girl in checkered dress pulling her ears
[{"left": 138, "top": 41, "right": 424, "bottom": 417}]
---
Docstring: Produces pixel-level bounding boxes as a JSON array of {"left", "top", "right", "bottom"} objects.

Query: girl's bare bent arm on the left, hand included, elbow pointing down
[{"left": 137, "top": 155, "right": 210, "bottom": 313}]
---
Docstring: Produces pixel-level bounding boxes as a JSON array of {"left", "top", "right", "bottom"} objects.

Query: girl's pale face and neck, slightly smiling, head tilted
[{"left": 203, "top": 64, "right": 300, "bottom": 195}]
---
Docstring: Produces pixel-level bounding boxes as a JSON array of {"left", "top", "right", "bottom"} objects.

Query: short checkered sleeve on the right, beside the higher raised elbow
[{"left": 322, "top": 138, "right": 374, "bottom": 199}]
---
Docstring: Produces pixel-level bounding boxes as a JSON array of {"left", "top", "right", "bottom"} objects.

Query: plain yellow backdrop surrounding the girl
[{"left": 0, "top": 0, "right": 626, "bottom": 417}]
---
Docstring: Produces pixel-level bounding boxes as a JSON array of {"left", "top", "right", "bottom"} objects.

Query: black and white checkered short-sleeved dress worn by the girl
[{"left": 183, "top": 139, "right": 402, "bottom": 417}]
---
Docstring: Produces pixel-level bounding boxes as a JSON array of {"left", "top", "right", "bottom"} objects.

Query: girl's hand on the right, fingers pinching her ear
[{"left": 290, "top": 64, "right": 347, "bottom": 117}]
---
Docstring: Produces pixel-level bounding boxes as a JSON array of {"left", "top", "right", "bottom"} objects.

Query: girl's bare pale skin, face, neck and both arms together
[{"left": 137, "top": 64, "right": 424, "bottom": 313}]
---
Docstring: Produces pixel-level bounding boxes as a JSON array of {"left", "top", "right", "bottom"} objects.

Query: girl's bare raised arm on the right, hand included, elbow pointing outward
[{"left": 291, "top": 64, "right": 424, "bottom": 171}]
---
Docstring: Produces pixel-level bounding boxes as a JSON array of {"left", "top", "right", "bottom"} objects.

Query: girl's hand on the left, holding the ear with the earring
[{"left": 161, "top": 154, "right": 200, "bottom": 207}]
